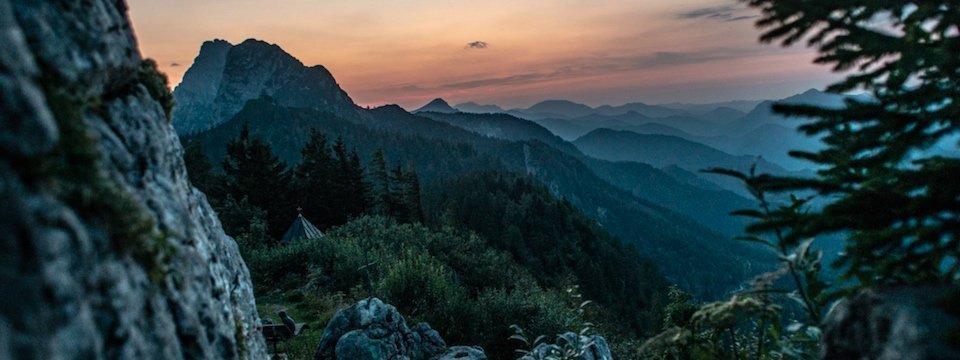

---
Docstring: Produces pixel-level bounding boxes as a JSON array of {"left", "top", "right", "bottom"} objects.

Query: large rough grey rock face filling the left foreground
[{"left": 0, "top": 0, "right": 266, "bottom": 359}]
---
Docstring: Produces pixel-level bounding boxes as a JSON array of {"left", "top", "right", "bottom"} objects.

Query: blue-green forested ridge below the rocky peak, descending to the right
[{"left": 189, "top": 98, "right": 770, "bottom": 297}]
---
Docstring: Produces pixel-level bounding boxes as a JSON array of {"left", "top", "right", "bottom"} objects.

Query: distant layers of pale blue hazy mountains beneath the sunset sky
[{"left": 436, "top": 89, "right": 864, "bottom": 171}]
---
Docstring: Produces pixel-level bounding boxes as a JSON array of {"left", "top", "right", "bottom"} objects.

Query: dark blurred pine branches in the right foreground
[{"left": 740, "top": 0, "right": 960, "bottom": 285}]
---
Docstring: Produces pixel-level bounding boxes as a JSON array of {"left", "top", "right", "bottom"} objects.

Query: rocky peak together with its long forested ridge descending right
[{"left": 173, "top": 40, "right": 774, "bottom": 296}]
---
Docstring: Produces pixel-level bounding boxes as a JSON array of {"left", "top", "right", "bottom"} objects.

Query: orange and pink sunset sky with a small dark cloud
[{"left": 129, "top": 0, "right": 837, "bottom": 109}]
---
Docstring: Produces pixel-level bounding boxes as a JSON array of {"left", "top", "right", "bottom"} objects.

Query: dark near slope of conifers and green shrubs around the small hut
[{"left": 186, "top": 125, "right": 669, "bottom": 356}]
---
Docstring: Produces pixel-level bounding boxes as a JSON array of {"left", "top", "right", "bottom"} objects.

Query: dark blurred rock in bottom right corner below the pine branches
[{"left": 821, "top": 286, "right": 960, "bottom": 360}]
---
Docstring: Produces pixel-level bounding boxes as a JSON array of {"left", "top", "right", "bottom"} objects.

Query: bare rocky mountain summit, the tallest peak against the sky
[{"left": 173, "top": 39, "right": 358, "bottom": 134}]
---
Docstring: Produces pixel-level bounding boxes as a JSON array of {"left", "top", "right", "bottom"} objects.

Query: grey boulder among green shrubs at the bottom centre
[{"left": 314, "top": 298, "right": 486, "bottom": 360}]
